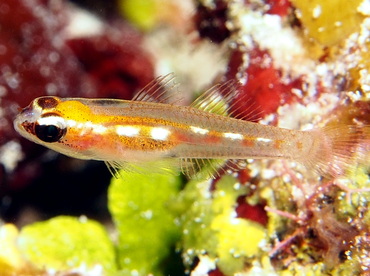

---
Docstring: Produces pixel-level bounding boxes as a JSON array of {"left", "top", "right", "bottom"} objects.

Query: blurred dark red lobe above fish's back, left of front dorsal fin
[{"left": 66, "top": 31, "right": 154, "bottom": 100}]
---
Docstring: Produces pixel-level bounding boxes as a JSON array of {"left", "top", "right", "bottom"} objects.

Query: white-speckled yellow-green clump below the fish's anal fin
[{"left": 175, "top": 176, "right": 265, "bottom": 275}]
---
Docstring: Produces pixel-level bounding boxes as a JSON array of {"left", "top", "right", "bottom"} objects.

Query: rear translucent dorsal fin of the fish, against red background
[{"left": 191, "top": 77, "right": 261, "bottom": 121}]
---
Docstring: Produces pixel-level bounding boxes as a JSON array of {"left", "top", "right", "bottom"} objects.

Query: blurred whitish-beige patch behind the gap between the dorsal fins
[{"left": 145, "top": 27, "right": 227, "bottom": 94}]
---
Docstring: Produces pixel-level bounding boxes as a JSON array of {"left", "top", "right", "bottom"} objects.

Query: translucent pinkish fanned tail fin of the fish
[{"left": 304, "top": 125, "right": 370, "bottom": 177}]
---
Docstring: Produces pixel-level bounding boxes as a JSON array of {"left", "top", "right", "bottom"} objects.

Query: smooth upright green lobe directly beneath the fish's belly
[{"left": 109, "top": 171, "right": 181, "bottom": 275}]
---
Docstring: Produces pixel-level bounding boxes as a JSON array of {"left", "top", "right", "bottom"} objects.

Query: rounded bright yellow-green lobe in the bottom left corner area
[{"left": 18, "top": 216, "right": 116, "bottom": 275}]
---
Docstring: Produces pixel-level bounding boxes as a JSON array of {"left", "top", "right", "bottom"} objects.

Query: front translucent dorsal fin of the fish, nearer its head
[{"left": 132, "top": 73, "right": 181, "bottom": 104}]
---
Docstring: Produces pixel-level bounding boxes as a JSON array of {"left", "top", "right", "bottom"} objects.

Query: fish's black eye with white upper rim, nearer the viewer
[{"left": 34, "top": 116, "right": 67, "bottom": 143}]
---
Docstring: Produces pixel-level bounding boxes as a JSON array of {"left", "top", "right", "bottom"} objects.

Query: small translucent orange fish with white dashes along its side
[{"left": 14, "top": 75, "right": 369, "bottom": 176}]
